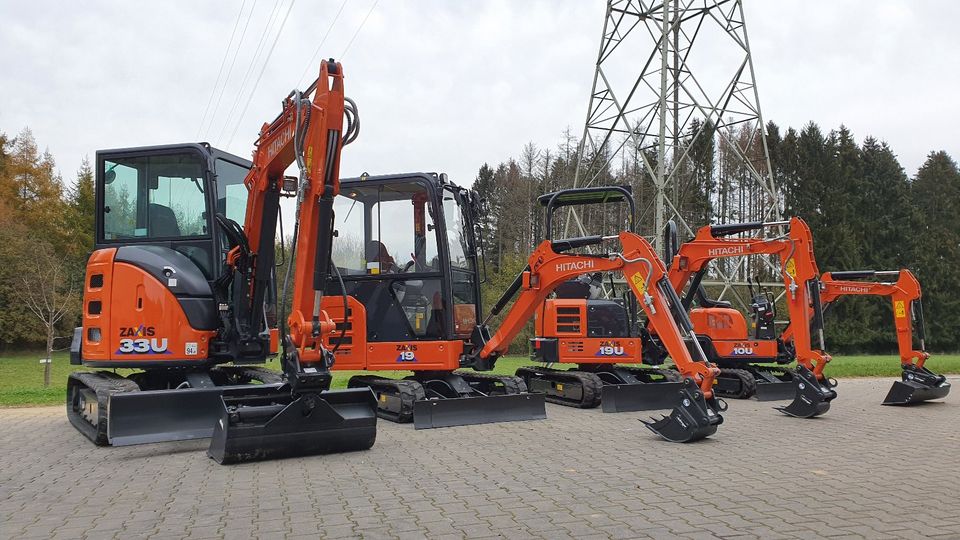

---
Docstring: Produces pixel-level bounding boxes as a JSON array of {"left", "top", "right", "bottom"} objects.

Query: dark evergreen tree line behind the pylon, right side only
[{"left": 474, "top": 122, "right": 960, "bottom": 353}]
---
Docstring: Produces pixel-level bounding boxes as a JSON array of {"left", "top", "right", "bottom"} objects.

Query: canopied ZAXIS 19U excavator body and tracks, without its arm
[{"left": 517, "top": 186, "right": 684, "bottom": 412}]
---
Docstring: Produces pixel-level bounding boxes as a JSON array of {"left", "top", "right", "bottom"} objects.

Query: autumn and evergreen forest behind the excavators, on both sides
[{"left": 0, "top": 122, "right": 960, "bottom": 353}]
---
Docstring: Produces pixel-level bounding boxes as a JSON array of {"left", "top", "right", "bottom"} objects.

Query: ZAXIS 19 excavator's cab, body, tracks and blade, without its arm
[{"left": 323, "top": 173, "right": 546, "bottom": 428}]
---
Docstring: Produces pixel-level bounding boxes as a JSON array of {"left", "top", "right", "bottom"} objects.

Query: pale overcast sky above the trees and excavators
[{"left": 0, "top": 0, "right": 960, "bottom": 194}]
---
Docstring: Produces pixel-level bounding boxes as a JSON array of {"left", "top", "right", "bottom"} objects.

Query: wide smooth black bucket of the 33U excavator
[{"left": 207, "top": 385, "right": 377, "bottom": 464}]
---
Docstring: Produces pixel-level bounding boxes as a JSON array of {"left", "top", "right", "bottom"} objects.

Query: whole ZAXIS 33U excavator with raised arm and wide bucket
[{"left": 67, "top": 60, "right": 376, "bottom": 463}]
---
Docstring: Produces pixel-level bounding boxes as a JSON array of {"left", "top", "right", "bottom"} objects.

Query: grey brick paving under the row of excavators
[{"left": 0, "top": 378, "right": 960, "bottom": 539}]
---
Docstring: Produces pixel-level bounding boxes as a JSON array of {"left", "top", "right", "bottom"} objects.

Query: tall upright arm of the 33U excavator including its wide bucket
[{"left": 208, "top": 60, "right": 376, "bottom": 463}]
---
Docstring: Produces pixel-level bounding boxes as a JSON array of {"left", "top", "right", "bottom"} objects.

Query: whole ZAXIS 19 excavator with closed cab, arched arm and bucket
[{"left": 323, "top": 180, "right": 725, "bottom": 442}]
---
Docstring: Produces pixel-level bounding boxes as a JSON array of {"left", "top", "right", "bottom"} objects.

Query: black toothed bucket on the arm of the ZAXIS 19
[{"left": 641, "top": 379, "right": 723, "bottom": 442}]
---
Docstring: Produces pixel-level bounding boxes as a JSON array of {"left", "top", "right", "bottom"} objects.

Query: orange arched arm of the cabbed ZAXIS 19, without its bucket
[{"left": 474, "top": 232, "right": 720, "bottom": 399}]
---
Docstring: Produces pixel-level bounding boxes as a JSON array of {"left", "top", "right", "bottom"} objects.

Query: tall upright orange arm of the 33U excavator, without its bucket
[{"left": 228, "top": 60, "right": 359, "bottom": 370}]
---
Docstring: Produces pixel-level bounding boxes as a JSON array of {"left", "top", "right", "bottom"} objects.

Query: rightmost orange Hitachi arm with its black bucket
[{"left": 783, "top": 269, "right": 950, "bottom": 405}]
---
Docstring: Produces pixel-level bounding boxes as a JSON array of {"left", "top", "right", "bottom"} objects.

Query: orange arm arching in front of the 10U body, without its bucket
[{"left": 669, "top": 217, "right": 830, "bottom": 379}]
